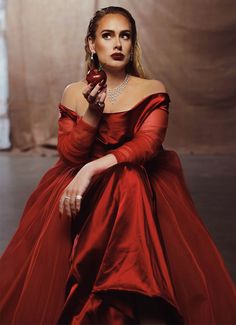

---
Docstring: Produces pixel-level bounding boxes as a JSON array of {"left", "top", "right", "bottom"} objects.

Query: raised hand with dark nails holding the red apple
[{"left": 83, "top": 81, "right": 107, "bottom": 114}]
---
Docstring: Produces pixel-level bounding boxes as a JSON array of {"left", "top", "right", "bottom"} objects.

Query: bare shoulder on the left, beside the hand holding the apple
[{"left": 61, "top": 80, "right": 86, "bottom": 112}]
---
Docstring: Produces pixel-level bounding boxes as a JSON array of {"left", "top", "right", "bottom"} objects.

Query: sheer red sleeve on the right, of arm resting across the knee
[{"left": 109, "top": 96, "right": 170, "bottom": 164}]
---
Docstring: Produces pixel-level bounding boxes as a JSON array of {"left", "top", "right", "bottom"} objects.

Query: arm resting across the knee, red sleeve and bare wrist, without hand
[{"left": 86, "top": 100, "right": 169, "bottom": 174}]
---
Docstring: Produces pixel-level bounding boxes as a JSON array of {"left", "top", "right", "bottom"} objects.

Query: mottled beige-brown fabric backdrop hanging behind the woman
[{"left": 7, "top": 0, "right": 236, "bottom": 153}]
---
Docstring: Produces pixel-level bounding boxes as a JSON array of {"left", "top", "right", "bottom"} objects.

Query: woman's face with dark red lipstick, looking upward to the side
[{"left": 89, "top": 14, "right": 132, "bottom": 70}]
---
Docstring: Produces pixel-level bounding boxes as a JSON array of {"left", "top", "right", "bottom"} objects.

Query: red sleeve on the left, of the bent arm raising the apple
[{"left": 57, "top": 104, "right": 97, "bottom": 165}]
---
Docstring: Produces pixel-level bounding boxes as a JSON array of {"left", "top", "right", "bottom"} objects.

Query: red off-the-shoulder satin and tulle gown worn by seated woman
[{"left": 0, "top": 93, "right": 236, "bottom": 325}]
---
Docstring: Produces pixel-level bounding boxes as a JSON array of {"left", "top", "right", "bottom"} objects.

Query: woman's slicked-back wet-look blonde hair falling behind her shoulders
[{"left": 84, "top": 6, "right": 147, "bottom": 79}]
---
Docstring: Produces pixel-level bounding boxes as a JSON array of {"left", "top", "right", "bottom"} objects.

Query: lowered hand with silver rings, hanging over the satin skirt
[{"left": 59, "top": 165, "right": 93, "bottom": 218}]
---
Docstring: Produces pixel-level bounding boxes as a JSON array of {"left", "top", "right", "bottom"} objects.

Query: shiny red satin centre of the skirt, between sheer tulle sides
[{"left": 59, "top": 163, "right": 183, "bottom": 324}]
